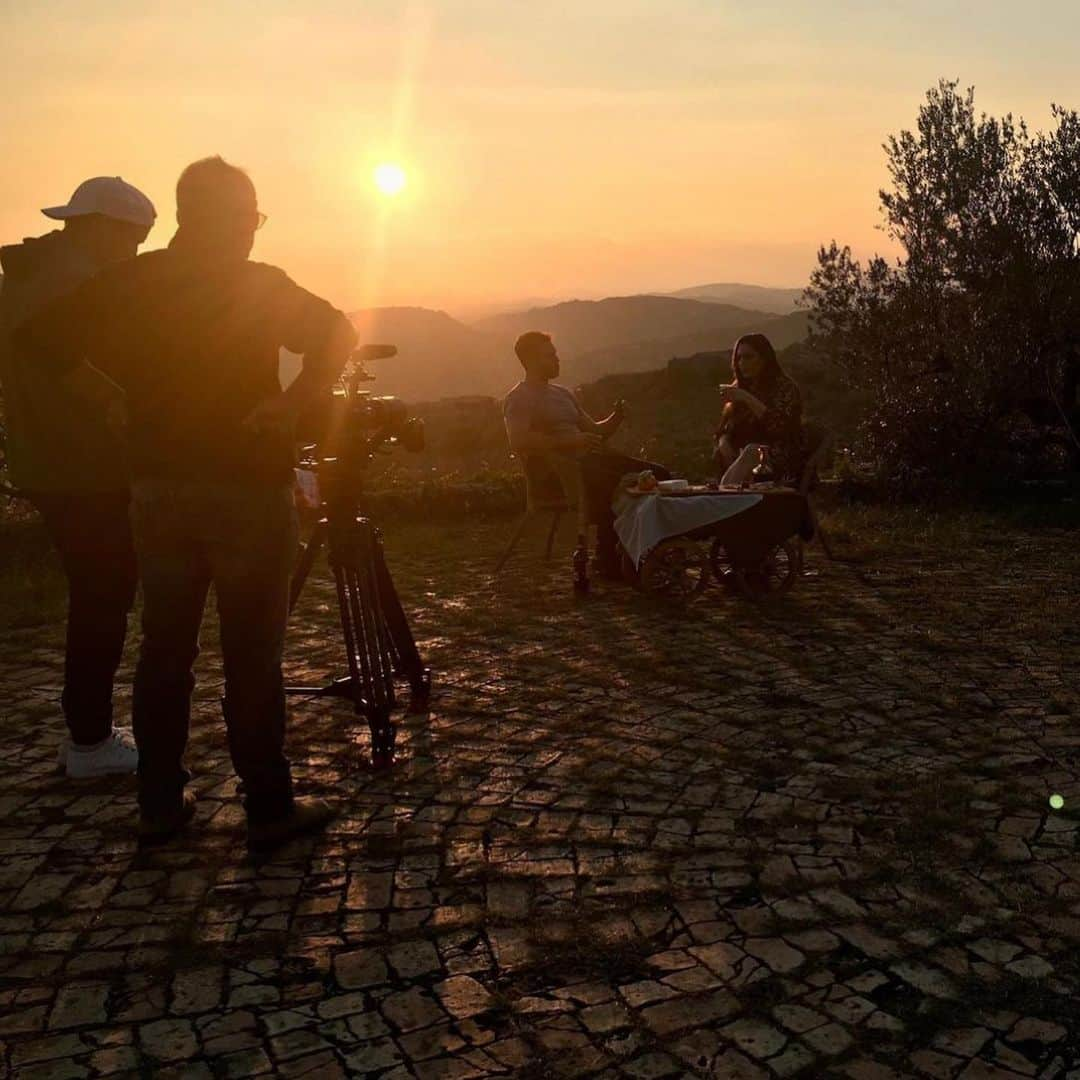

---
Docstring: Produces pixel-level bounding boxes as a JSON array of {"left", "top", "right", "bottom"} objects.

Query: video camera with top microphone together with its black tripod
[{"left": 286, "top": 345, "right": 431, "bottom": 769}]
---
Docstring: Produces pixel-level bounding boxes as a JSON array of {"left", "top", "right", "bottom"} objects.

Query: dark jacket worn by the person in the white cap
[{"left": 0, "top": 231, "right": 127, "bottom": 494}]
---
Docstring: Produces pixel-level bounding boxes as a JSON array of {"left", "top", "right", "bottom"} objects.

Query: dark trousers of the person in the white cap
[{"left": 28, "top": 491, "right": 137, "bottom": 745}]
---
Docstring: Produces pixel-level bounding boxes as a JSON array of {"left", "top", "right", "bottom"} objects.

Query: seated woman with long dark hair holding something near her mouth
[{"left": 715, "top": 334, "right": 805, "bottom": 481}]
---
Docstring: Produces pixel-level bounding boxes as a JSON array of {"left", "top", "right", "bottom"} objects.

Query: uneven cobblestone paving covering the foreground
[{"left": 0, "top": 525, "right": 1080, "bottom": 1080}]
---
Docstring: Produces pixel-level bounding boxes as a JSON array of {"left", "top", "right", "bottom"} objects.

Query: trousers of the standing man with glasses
[{"left": 132, "top": 481, "right": 298, "bottom": 822}]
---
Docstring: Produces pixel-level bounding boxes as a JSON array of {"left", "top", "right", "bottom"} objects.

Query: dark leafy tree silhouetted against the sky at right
[{"left": 806, "top": 81, "right": 1080, "bottom": 489}]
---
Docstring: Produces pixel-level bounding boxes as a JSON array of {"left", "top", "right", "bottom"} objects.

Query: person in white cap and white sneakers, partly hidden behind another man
[{"left": 0, "top": 176, "right": 157, "bottom": 779}]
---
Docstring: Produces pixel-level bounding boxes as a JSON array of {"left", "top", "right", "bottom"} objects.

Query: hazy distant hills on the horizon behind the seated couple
[{"left": 336, "top": 286, "right": 807, "bottom": 402}]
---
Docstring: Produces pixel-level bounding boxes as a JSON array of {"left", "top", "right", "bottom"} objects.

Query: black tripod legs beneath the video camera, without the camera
[{"left": 285, "top": 498, "right": 431, "bottom": 769}]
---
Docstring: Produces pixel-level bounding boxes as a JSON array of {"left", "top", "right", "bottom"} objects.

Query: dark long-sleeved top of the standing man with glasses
[{"left": 18, "top": 233, "right": 351, "bottom": 484}]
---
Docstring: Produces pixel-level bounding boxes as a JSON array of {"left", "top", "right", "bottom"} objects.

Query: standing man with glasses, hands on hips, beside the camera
[{"left": 22, "top": 158, "right": 356, "bottom": 849}]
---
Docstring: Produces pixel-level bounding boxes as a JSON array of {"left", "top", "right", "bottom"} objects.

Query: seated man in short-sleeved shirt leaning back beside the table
[{"left": 502, "top": 330, "right": 669, "bottom": 576}]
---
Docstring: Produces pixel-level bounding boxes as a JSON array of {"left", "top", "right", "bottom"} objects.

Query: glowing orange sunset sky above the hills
[{"left": 0, "top": 0, "right": 1080, "bottom": 312}]
